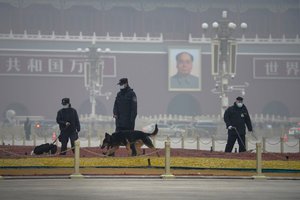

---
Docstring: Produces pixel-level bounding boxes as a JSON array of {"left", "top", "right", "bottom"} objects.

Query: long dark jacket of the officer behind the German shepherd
[{"left": 113, "top": 86, "right": 137, "bottom": 128}]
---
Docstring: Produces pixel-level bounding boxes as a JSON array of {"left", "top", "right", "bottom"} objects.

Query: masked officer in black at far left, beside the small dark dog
[{"left": 56, "top": 98, "right": 80, "bottom": 155}]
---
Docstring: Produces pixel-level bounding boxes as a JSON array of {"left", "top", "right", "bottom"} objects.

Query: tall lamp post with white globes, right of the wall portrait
[{"left": 202, "top": 11, "right": 249, "bottom": 116}]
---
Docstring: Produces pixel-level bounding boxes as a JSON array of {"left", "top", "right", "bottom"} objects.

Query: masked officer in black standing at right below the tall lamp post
[{"left": 224, "top": 97, "right": 252, "bottom": 152}]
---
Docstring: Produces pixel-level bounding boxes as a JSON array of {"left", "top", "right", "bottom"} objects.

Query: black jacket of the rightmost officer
[{"left": 224, "top": 103, "right": 252, "bottom": 134}]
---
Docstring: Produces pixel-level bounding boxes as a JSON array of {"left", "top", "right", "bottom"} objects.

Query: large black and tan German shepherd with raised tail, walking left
[{"left": 101, "top": 124, "right": 159, "bottom": 156}]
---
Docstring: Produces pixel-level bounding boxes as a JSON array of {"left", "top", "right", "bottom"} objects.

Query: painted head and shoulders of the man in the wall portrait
[{"left": 170, "top": 52, "right": 199, "bottom": 89}]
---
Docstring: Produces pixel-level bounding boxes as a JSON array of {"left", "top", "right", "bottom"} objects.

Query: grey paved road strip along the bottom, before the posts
[{"left": 0, "top": 178, "right": 300, "bottom": 200}]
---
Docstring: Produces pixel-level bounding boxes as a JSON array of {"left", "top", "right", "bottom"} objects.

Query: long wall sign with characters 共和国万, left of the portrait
[{"left": 0, "top": 52, "right": 116, "bottom": 77}]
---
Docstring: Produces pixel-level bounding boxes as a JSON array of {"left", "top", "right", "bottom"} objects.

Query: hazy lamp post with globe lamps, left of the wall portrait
[{"left": 77, "top": 45, "right": 111, "bottom": 117}]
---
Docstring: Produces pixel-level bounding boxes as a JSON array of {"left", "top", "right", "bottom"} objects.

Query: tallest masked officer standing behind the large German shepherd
[{"left": 113, "top": 78, "right": 137, "bottom": 156}]
